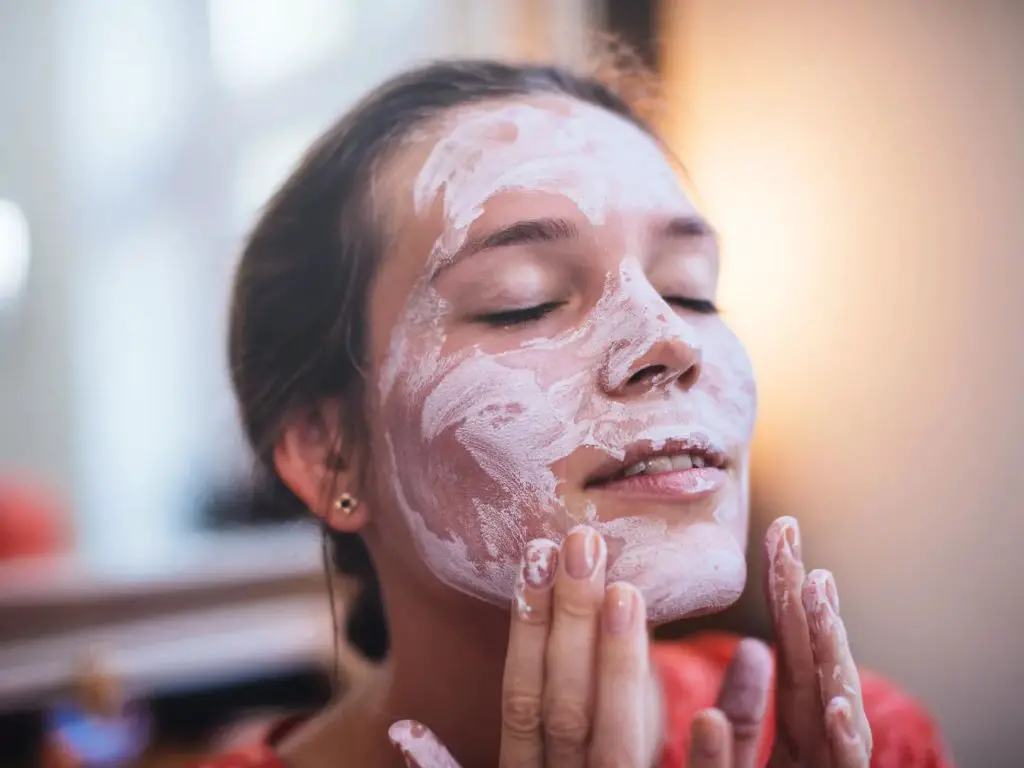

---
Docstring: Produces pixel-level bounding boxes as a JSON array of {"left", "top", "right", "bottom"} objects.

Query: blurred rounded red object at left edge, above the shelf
[{"left": 0, "top": 477, "right": 69, "bottom": 561}]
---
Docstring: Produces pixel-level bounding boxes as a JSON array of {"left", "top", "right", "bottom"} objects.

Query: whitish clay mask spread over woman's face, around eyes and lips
[{"left": 375, "top": 99, "right": 756, "bottom": 621}]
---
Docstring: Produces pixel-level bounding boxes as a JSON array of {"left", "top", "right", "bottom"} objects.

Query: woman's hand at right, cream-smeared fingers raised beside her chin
[{"left": 689, "top": 517, "right": 871, "bottom": 768}]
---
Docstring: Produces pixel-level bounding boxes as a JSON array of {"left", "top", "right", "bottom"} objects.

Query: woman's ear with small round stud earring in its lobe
[{"left": 273, "top": 400, "right": 369, "bottom": 534}]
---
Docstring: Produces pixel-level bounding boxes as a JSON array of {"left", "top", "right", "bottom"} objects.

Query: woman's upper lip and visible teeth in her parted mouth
[{"left": 586, "top": 437, "right": 730, "bottom": 488}]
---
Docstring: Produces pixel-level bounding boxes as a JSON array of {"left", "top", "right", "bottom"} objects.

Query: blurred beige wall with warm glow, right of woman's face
[{"left": 663, "top": 0, "right": 1024, "bottom": 766}]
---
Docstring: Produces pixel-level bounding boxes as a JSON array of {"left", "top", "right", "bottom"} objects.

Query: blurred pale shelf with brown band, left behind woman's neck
[{"left": 0, "top": 530, "right": 333, "bottom": 713}]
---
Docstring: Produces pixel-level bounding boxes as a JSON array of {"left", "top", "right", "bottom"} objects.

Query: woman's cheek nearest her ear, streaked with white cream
[{"left": 378, "top": 351, "right": 582, "bottom": 602}]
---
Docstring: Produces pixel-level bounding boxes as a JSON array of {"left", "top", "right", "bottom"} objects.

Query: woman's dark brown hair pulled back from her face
[{"left": 228, "top": 55, "right": 650, "bottom": 658}]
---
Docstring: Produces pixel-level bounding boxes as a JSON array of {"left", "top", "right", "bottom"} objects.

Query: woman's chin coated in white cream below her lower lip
[{"left": 608, "top": 520, "right": 746, "bottom": 624}]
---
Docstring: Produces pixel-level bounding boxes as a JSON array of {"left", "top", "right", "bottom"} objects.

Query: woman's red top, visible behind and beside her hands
[{"left": 196, "top": 633, "right": 953, "bottom": 768}]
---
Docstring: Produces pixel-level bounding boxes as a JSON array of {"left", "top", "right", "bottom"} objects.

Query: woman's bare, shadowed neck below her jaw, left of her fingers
[{"left": 282, "top": 573, "right": 509, "bottom": 768}]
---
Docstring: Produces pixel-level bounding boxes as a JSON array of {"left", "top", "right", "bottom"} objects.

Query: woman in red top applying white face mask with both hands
[{"left": 201, "top": 61, "right": 948, "bottom": 768}]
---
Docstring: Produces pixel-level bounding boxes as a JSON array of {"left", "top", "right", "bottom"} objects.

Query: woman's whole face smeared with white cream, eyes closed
[{"left": 370, "top": 96, "right": 756, "bottom": 621}]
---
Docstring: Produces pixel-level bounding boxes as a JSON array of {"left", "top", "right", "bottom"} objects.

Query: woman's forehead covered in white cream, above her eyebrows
[{"left": 382, "top": 95, "right": 695, "bottom": 236}]
